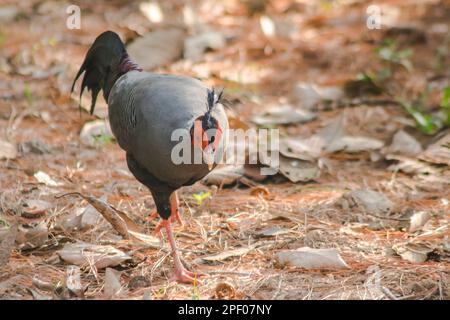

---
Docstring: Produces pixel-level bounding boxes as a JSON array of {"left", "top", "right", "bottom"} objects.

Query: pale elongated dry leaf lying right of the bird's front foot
[{"left": 276, "top": 247, "right": 348, "bottom": 269}]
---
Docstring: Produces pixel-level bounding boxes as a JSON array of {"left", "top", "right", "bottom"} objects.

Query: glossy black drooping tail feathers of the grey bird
[{"left": 71, "top": 31, "right": 126, "bottom": 114}]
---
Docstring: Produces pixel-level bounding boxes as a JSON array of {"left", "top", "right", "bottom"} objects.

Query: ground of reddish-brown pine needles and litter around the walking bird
[{"left": 0, "top": 0, "right": 450, "bottom": 300}]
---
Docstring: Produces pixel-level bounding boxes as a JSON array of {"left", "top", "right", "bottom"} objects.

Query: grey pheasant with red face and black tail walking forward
[{"left": 71, "top": 31, "right": 228, "bottom": 283}]
